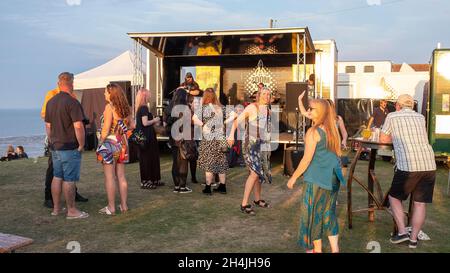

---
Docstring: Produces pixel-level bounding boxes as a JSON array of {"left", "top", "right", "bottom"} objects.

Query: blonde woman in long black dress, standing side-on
[{"left": 136, "top": 88, "right": 164, "bottom": 189}]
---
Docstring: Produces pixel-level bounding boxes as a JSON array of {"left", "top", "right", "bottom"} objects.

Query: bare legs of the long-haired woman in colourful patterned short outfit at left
[{"left": 103, "top": 163, "right": 128, "bottom": 213}]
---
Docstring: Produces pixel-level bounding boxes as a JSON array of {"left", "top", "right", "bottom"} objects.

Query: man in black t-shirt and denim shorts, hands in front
[{"left": 45, "top": 72, "right": 89, "bottom": 219}]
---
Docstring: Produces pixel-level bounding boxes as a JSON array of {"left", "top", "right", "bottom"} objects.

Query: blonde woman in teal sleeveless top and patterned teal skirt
[{"left": 287, "top": 99, "right": 345, "bottom": 253}]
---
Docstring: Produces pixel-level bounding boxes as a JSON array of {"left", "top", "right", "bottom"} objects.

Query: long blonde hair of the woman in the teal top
[{"left": 310, "top": 99, "right": 342, "bottom": 156}]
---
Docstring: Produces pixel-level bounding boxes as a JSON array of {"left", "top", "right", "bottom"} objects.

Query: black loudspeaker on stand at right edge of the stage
[{"left": 284, "top": 82, "right": 308, "bottom": 130}]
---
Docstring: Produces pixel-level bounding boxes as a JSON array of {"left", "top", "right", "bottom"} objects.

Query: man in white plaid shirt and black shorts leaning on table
[{"left": 380, "top": 94, "right": 436, "bottom": 248}]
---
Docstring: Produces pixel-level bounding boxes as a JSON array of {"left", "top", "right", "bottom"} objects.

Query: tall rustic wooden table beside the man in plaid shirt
[{"left": 347, "top": 138, "right": 393, "bottom": 229}]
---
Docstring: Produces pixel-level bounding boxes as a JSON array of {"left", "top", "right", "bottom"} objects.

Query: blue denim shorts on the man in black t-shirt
[{"left": 52, "top": 150, "right": 81, "bottom": 182}]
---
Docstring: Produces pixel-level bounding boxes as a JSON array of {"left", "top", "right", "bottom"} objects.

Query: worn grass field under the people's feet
[{"left": 0, "top": 146, "right": 450, "bottom": 253}]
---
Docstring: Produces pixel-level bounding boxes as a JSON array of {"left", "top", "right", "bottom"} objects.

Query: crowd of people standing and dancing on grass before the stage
[{"left": 38, "top": 72, "right": 436, "bottom": 252}]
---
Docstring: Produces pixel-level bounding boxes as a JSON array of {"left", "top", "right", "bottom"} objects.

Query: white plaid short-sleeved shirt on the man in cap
[{"left": 382, "top": 108, "right": 436, "bottom": 172}]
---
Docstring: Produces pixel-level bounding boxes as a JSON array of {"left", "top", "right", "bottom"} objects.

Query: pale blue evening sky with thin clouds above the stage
[{"left": 0, "top": 0, "right": 450, "bottom": 109}]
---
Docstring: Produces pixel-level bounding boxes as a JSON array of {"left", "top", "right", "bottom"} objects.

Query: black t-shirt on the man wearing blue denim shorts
[{"left": 45, "top": 91, "right": 84, "bottom": 150}]
